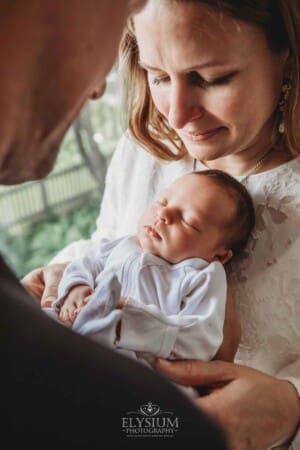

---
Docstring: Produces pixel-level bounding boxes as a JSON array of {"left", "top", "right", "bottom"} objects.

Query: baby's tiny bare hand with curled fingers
[{"left": 59, "top": 284, "right": 93, "bottom": 326}]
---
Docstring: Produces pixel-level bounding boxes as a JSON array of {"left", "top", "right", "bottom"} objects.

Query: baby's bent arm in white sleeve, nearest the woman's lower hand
[{"left": 117, "top": 263, "right": 226, "bottom": 360}]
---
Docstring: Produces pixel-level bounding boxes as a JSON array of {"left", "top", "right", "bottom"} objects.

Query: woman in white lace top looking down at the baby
[{"left": 25, "top": 0, "right": 300, "bottom": 450}]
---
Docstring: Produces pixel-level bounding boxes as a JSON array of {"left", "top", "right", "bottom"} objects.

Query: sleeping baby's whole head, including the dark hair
[{"left": 138, "top": 170, "right": 255, "bottom": 264}]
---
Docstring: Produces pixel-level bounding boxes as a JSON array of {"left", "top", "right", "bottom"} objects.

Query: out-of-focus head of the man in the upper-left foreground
[{"left": 0, "top": 0, "right": 146, "bottom": 184}]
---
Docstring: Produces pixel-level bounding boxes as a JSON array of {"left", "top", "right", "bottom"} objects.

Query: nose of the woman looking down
[{"left": 168, "top": 84, "right": 204, "bottom": 129}]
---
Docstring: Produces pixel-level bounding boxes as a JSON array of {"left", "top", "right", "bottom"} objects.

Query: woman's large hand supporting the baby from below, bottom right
[{"left": 156, "top": 359, "right": 300, "bottom": 450}]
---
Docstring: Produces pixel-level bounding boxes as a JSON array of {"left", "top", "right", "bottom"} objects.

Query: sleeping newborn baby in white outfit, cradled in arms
[{"left": 48, "top": 170, "right": 255, "bottom": 365}]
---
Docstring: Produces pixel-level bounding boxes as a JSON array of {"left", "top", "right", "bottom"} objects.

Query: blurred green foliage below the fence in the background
[{"left": 0, "top": 199, "right": 99, "bottom": 278}]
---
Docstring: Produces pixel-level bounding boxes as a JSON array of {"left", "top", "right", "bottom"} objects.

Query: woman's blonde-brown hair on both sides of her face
[{"left": 120, "top": 0, "right": 300, "bottom": 161}]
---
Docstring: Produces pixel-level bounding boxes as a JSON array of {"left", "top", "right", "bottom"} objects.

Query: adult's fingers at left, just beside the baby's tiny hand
[{"left": 21, "top": 263, "right": 68, "bottom": 307}]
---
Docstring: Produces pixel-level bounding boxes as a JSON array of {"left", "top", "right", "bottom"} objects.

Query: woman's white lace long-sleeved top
[{"left": 55, "top": 130, "right": 300, "bottom": 449}]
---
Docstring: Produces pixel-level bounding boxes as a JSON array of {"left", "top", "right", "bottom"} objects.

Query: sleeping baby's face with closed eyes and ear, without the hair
[{"left": 138, "top": 174, "right": 235, "bottom": 264}]
